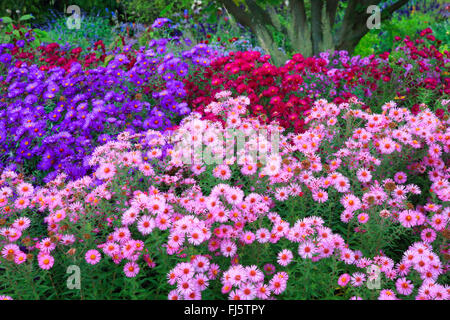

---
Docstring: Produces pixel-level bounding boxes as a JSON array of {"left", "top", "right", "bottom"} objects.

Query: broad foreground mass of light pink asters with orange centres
[{"left": 0, "top": 91, "right": 450, "bottom": 299}]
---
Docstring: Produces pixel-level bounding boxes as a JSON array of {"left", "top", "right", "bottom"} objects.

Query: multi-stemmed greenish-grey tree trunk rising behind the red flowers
[{"left": 217, "top": 0, "right": 408, "bottom": 61}]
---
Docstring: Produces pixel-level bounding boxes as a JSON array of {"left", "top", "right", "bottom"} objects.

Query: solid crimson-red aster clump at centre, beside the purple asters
[{"left": 185, "top": 51, "right": 324, "bottom": 131}]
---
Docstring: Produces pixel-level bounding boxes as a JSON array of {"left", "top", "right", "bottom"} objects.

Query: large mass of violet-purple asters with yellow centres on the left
[{"left": 0, "top": 33, "right": 213, "bottom": 181}]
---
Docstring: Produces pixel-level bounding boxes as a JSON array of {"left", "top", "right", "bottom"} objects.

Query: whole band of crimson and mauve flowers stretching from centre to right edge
[{"left": 185, "top": 29, "right": 450, "bottom": 132}]
